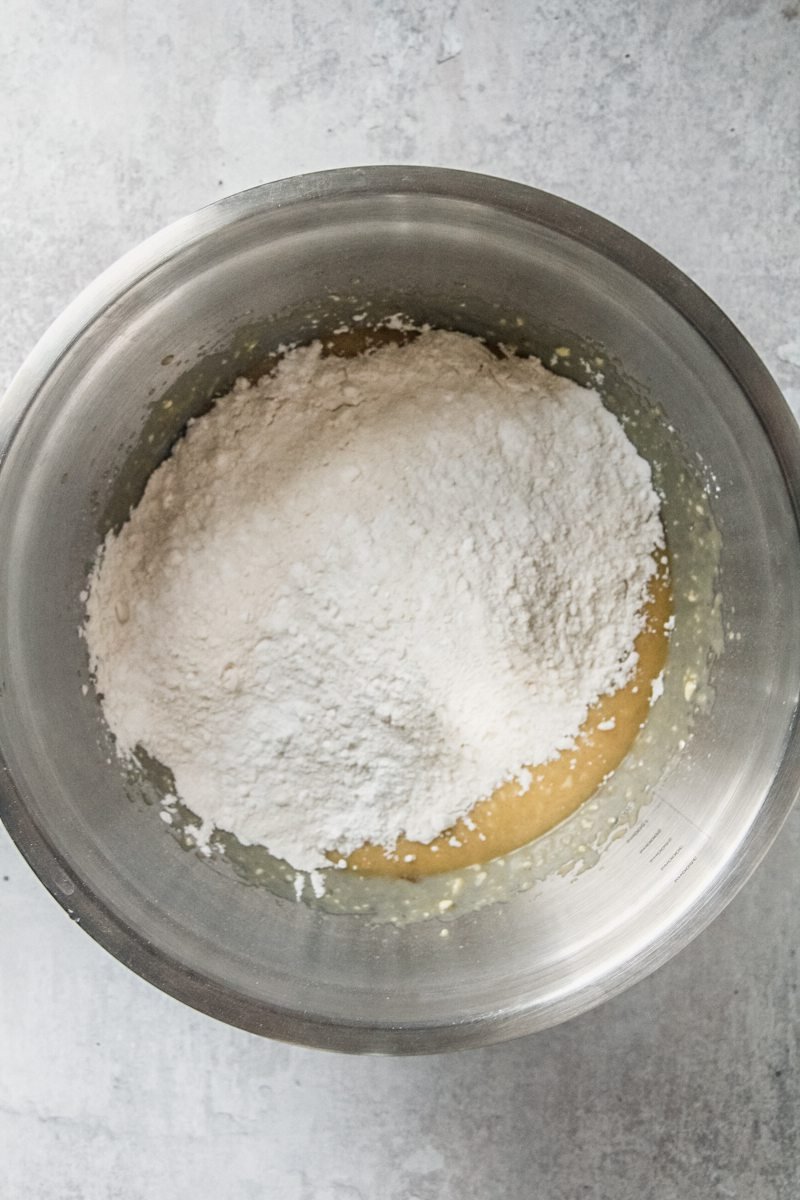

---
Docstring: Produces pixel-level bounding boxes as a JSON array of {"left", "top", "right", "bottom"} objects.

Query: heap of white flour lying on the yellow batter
[{"left": 86, "top": 332, "right": 662, "bottom": 870}]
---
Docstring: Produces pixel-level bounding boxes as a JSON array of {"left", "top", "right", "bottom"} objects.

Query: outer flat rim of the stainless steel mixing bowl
[{"left": 0, "top": 166, "right": 800, "bottom": 1054}]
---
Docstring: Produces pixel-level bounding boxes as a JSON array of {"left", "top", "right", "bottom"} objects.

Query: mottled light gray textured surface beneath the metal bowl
[{"left": 0, "top": 0, "right": 800, "bottom": 1200}]
